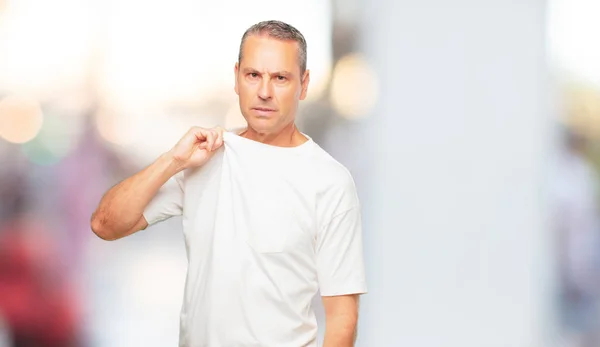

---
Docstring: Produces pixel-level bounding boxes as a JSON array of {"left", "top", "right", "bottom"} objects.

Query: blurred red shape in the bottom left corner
[{"left": 0, "top": 219, "right": 81, "bottom": 346}]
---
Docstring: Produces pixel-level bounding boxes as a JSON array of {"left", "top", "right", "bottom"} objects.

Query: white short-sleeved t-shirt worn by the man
[{"left": 144, "top": 132, "right": 367, "bottom": 347}]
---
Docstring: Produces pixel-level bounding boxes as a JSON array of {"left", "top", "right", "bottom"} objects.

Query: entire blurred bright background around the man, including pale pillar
[{"left": 0, "top": 0, "right": 600, "bottom": 347}]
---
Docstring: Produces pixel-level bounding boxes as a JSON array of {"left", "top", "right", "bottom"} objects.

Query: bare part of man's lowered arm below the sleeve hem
[{"left": 322, "top": 295, "right": 358, "bottom": 347}]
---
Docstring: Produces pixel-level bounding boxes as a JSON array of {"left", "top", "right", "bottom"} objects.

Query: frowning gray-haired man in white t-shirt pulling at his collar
[{"left": 91, "top": 21, "right": 366, "bottom": 347}]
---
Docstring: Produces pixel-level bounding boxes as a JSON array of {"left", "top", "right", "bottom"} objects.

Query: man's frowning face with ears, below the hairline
[{"left": 235, "top": 35, "right": 309, "bottom": 134}]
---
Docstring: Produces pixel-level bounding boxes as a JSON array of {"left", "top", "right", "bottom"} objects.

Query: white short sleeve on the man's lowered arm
[{"left": 316, "top": 206, "right": 367, "bottom": 296}]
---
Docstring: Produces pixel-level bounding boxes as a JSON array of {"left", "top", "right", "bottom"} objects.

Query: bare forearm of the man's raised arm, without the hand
[{"left": 91, "top": 153, "right": 181, "bottom": 240}]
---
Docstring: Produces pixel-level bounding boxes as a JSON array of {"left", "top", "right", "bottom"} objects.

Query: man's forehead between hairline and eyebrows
[{"left": 240, "top": 35, "right": 300, "bottom": 71}]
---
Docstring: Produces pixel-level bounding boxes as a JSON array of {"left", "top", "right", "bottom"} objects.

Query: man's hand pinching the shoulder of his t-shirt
[{"left": 169, "top": 127, "right": 224, "bottom": 170}]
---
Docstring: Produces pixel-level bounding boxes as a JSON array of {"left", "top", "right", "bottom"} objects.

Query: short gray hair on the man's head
[{"left": 238, "top": 20, "right": 306, "bottom": 74}]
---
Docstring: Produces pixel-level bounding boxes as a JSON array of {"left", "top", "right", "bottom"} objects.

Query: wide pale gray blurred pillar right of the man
[{"left": 346, "top": 0, "right": 554, "bottom": 347}]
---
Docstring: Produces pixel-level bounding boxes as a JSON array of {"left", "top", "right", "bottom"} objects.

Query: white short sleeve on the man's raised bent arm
[{"left": 143, "top": 171, "right": 183, "bottom": 225}]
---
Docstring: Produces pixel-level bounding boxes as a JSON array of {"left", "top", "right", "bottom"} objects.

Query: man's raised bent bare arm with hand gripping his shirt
[{"left": 90, "top": 127, "right": 223, "bottom": 240}]
